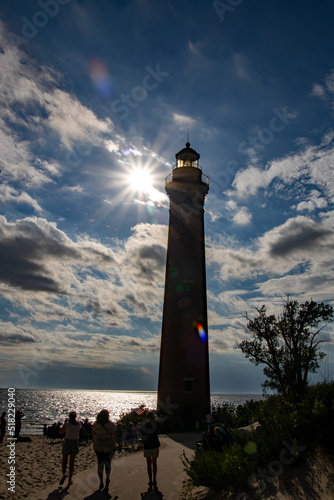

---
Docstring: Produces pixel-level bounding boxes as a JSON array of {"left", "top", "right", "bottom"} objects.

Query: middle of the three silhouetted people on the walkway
[{"left": 92, "top": 410, "right": 122, "bottom": 490}]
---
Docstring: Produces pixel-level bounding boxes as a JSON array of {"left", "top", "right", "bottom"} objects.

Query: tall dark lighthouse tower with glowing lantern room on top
[{"left": 158, "top": 142, "right": 210, "bottom": 428}]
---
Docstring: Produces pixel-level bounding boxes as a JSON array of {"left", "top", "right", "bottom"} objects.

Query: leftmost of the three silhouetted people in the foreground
[{"left": 59, "top": 411, "right": 81, "bottom": 485}]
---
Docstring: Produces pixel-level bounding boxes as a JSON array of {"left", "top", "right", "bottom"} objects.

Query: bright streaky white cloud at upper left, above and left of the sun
[{"left": 0, "top": 19, "right": 113, "bottom": 192}]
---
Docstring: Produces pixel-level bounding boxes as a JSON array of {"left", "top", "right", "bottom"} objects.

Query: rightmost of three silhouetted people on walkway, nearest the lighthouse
[{"left": 140, "top": 411, "right": 160, "bottom": 486}]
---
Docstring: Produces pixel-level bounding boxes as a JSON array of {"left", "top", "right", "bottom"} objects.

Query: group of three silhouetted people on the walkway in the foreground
[{"left": 59, "top": 410, "right": 160, "bottom": 490}]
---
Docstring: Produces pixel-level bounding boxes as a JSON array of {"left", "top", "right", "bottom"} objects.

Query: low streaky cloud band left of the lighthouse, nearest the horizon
[{"left": 0, "top": 321, "right": 160, "bottom": 374}]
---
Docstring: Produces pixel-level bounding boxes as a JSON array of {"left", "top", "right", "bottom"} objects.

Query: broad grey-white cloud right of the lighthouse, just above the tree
[{"left": 207, "top": 216, "right": 334, "bottom": 300}]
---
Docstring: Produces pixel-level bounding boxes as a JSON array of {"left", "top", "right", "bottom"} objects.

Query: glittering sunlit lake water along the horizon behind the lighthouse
[{"left": 0, "top": 389, "right": 262, "bottom": 434}]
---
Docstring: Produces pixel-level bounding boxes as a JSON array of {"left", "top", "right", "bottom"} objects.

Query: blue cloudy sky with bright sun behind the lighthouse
[{"left": 0, "top": 0, "right": 334, "bottom": 393}]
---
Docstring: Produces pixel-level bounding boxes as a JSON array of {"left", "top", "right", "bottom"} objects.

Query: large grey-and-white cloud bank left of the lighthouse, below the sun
[{"left": 0, "top": 217, "right": 167, "bottom": 330}]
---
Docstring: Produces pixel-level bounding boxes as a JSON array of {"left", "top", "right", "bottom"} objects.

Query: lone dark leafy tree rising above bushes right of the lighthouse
[{"left": 237, "top": 297, "right": 334, "bottom": 397}]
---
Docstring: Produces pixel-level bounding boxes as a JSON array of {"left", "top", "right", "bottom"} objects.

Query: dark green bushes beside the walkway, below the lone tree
[{"left": 182, "top": 382, "right": 334, "bottom": 498}]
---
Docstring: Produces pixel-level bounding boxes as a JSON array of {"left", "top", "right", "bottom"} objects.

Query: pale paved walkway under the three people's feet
[{"left": 27, "top": 433, "right": 200, "bottom": 500}]
